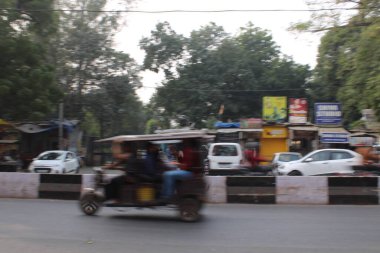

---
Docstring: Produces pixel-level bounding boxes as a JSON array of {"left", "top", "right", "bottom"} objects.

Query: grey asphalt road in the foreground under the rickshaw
[{"left": 0, "top": 199, "right": 380, "bottom": 253}]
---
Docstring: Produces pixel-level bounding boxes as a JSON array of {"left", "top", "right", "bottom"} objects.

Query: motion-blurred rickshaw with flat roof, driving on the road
[{"left": 79, "top": 131, "right": 211, "bottom": 222}]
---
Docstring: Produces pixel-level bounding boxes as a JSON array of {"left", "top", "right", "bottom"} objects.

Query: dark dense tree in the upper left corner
[{"left": 0, "top": 0, "right": 61, "bottom": 121}]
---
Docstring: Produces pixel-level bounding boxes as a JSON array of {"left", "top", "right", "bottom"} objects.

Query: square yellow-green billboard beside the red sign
[{"left": 263, "top": 97, "right": 287, "bottom": 123}]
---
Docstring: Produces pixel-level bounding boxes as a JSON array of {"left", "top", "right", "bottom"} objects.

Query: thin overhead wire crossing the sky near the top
[{"left": 0, "top": 7, "right": 374, "bottom": 14}]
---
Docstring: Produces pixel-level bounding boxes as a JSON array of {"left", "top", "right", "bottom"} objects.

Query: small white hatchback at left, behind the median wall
[{"left": 28, "top": 150, "right": 80, "bottom": 174}]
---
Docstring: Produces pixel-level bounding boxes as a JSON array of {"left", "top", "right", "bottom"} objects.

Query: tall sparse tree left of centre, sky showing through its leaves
[{"left": 55, "top": 0, "right": 145, "bottom": 137}]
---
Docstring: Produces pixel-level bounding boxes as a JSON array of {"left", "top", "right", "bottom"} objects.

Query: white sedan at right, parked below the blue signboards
[{"left": 274, "top": 149, "right": 363, "bottom": 176}]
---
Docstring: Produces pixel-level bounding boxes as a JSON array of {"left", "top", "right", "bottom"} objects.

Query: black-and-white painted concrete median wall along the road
[{"left": 0, "top": 172, "right": 380, "bottom": 205}]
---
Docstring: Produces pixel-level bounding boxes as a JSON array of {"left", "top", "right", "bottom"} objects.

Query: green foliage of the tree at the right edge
[{"left": 310, "top": 0, "right": 380, "bottom": 124}]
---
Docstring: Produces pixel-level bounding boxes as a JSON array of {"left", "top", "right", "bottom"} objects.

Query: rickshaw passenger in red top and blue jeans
[{"left": 161, "top": 139, "right": 197, "bottom": 201}]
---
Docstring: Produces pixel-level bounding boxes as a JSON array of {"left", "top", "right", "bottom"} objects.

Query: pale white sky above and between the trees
[{"left": 113, "top": 0, "right": 321, "bottom": 103}]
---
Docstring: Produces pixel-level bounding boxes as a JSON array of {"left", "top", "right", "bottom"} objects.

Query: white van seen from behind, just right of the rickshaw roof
[{"left": 207, "top": 142, "right": 243, "bottom": 171}]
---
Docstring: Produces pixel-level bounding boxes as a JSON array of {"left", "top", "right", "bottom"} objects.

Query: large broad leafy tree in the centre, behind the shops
[{"left": 140, "top": 23, "right": 309, "bottom": 127}]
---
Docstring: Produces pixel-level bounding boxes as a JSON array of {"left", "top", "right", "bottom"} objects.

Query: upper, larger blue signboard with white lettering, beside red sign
[{"left": 314, "top": 103, "right": 342, "bottom": 125}]
